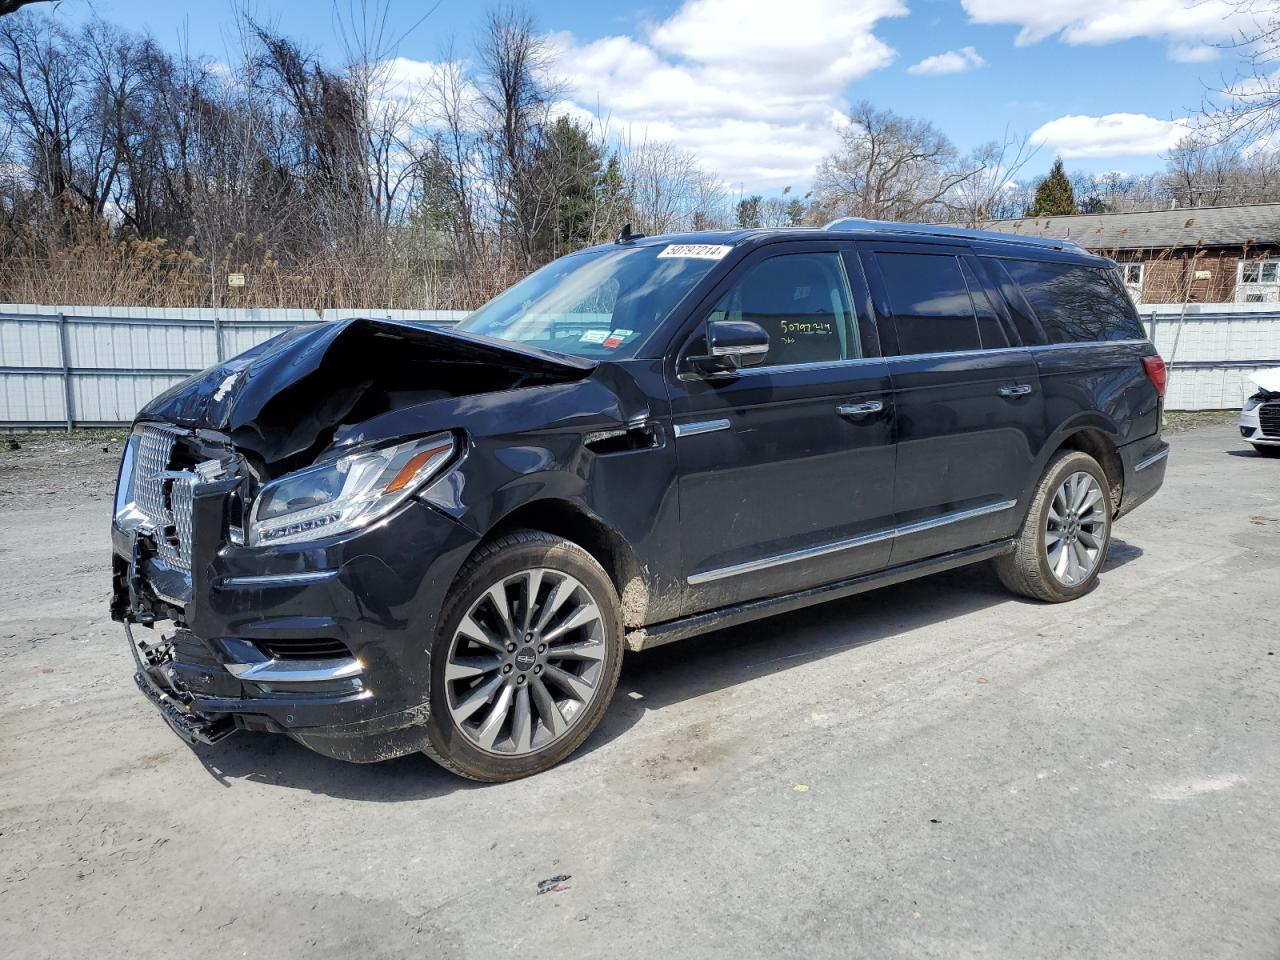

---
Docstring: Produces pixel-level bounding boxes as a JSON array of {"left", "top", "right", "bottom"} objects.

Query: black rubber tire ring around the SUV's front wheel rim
[{"left": 426, "top": 532, "right": 622, "bottom": 781}]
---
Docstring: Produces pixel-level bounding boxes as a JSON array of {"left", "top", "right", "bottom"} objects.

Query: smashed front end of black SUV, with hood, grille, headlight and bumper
[{"left": 111, "top": 320, "right": 594, "bottom": 760}]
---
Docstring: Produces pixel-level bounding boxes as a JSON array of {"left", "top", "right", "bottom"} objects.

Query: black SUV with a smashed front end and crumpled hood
[{"left": 111, "top": 220, "right": 1169, "bottom": 781}]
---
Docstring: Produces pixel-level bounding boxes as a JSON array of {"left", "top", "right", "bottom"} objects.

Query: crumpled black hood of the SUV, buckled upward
[{"left": 138, "top": 317, "right": 595, "bottom": 462}]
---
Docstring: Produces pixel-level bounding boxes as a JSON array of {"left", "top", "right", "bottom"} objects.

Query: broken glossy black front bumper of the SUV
[{"left": 111, "top": 484, "right": 476, "bottom": 762}]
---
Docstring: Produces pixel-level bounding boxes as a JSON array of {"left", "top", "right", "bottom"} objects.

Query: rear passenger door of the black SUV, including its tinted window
[{"left": 863, "top": 242, "right": 1044, "bottom": 564}]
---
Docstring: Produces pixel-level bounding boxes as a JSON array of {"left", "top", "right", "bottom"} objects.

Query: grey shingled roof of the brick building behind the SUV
[{"left": 983, "top": 204, "right": 1280, "bottom": 251}]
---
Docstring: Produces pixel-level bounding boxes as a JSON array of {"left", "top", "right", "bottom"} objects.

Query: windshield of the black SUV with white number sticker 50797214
[{"left": 458, "top": 243, "right": 730, "bottom": 358}]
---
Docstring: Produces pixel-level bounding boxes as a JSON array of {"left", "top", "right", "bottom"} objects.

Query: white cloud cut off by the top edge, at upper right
[{"left": 961, "top": 0, "right": 1252, "bottom": 60}]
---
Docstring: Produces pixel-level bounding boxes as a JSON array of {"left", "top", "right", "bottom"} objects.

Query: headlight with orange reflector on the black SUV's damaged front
[{"left": 248, "top": 434, "right": 456, "bottom": 547}]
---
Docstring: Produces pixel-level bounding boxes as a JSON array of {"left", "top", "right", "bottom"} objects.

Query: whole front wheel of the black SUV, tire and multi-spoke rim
[{"left": 425, "top": 530, "right": 622, "bottom": 783}]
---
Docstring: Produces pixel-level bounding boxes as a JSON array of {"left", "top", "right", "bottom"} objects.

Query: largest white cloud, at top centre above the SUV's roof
[{"left": 552, "top": 0, "right": 908, "bottom": 189}]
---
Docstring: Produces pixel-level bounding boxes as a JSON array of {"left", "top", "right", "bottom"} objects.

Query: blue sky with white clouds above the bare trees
[{"left": 56, "top": 0, "right": 1240, "bottom": 191}]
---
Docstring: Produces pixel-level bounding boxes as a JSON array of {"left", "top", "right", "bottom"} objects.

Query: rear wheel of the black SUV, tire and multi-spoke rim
[{"left": 996, "top": 451, "right": 1114, "bottom": 603}]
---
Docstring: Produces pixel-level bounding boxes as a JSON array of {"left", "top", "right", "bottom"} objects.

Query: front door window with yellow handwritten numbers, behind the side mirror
[{"left": 707, "top": 252, "right": 861, "bottom": 366}]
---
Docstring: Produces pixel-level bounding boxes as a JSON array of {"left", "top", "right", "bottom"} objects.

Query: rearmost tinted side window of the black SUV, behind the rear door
[{"left": 1001, "top": 259, "right": 1147, "bottom": 343}]
